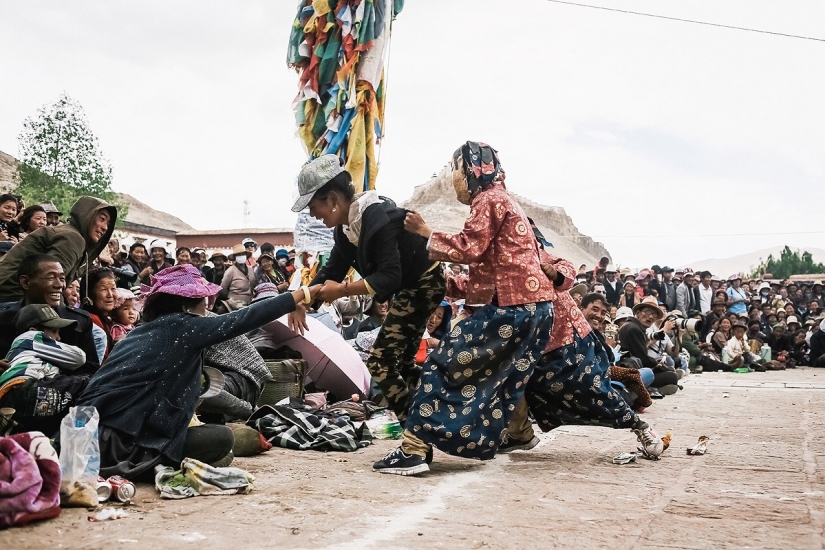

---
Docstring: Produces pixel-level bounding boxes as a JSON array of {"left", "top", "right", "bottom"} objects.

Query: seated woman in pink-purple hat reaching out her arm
[{"left": 78, "top": 264, "right": 320, "bottom": 478}]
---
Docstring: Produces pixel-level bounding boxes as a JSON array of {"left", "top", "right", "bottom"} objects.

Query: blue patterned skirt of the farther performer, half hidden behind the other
[{"left": 525, "top": 332, "right": 636, "bottom": 431}]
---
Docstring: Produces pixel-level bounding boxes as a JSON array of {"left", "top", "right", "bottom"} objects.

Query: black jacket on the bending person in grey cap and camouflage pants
[{"left": 311, "top": 197, "right": 433, "bottom": 302}]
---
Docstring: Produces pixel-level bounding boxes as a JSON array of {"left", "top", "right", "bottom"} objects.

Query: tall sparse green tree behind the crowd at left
[{"left": 16, "top": 93, "right": 125, "bottom": 220}]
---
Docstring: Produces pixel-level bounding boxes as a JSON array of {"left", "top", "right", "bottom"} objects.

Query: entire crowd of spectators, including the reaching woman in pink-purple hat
[{"left": 0, "top": 195, "right": 825, "bottom": 478}]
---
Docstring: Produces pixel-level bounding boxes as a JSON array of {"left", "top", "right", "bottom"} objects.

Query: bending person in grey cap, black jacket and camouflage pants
[{"left": 292, "top": 155, "right": 445, "bottom": 420}]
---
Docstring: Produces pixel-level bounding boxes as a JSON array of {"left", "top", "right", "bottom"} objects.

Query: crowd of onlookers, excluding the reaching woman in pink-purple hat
[{"left": 0, "top": 195, "right": 825, "bottom": 444}]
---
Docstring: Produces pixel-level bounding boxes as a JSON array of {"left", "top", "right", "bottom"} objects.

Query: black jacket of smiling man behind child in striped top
[{"left": 0, "top": 300, "right": 100, "bottom": 374}]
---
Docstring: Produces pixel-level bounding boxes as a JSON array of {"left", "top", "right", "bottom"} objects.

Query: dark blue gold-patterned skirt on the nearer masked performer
[{"left": 405, "top": 302, "right": 553, "bottom": 460}]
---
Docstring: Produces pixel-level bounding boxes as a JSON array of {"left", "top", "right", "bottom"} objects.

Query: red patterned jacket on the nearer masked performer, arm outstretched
[{"left": 429, "top": 182, "right": 556, "bottom": 307}]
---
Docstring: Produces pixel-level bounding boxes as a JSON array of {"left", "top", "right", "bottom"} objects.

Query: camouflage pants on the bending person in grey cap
[{"left": 367, "top": 266, "right": 446, "bottom": 420}]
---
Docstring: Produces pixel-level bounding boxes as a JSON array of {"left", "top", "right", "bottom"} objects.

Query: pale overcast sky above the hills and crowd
[{"left": 0, "top": 0, "right": 825, "bottom": 266}]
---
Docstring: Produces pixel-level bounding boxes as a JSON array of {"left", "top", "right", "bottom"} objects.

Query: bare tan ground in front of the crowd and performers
[{"left": 0, "top": 369, "right": 825, "bottom": 550}]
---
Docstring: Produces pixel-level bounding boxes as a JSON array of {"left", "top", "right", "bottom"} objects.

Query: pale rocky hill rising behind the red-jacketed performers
[{"left": 402, "top": 171, "right": 610, "bottom": 267}]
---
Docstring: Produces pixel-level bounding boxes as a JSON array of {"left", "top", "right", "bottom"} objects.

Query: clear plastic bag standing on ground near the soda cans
[{"left": 60, "top": 407, "right": 100, "bottom": 506}]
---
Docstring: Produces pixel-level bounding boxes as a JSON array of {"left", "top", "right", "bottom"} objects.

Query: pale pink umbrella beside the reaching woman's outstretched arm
[{"left": 263, "top": 316, "right": 370, "bottom": 399}]
